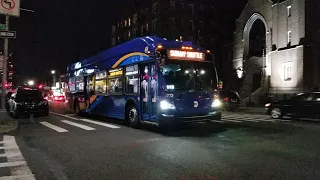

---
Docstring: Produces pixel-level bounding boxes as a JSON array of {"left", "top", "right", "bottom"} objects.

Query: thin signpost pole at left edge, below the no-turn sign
[{"left": 1, "top": 15, "right": 9, "bottom": 110}]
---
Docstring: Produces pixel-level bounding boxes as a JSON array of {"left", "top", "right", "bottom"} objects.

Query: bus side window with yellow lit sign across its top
[{"left": 108, "top": 68, "right": 123, "bottom": 94}]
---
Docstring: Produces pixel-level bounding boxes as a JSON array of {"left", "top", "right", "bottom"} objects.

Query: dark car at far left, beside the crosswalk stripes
[{"left": 8, "top": 89, "right": 49, "bottom": 118}]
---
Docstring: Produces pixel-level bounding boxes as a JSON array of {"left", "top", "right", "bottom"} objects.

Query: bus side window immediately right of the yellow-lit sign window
[{"left": 126, "top": 65, "right": 140, "bottom": 93}]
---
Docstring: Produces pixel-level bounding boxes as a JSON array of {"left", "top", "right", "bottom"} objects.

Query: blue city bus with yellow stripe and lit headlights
[{"left": 67, "top": 36, "right": 221, "bottom": 127}]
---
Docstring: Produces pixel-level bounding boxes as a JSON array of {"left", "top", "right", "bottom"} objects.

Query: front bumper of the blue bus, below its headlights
[{"left": 159, "top": 111, "right": 221, "bottom": 124}]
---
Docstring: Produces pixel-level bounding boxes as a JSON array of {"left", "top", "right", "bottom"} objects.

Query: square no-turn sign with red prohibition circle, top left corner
[{"left": 0, "top": 0, "right": 20, "bottom": 17}]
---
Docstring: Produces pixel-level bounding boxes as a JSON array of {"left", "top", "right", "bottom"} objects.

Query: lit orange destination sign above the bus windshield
[{"left": 168, "top": 50, "right": 205, "bottom": 61}]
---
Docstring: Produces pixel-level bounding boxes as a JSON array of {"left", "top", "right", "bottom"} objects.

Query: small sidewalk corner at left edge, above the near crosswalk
[{"left": 0, "top": 110, "right": 18, "bottom": 133}]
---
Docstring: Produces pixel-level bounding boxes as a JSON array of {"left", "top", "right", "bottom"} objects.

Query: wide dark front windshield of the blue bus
[{"left": 160, "top": 60, "right": 217, "bottom": 91}]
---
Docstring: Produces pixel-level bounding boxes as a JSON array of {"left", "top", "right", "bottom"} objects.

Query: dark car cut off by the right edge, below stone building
[{"left": 265, "top": 92, "right": 320, "bottom": 119}]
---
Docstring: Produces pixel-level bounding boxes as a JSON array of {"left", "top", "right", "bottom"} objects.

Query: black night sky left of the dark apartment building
[{"left": 1, "top": 0, "right": 122, "bottom": 82}]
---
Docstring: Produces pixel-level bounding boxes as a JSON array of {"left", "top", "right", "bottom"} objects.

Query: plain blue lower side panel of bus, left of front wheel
[{"left": 89, "top": 95, "right": 140, "bottom": 119}]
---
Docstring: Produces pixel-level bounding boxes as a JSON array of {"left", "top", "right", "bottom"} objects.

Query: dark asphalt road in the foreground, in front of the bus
[{"left": 0, "top": 101, "right": 320, "bottom": 180}]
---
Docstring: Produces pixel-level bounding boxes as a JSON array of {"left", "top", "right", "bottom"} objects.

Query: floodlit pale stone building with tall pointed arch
[{"left": 233, "top": 0, "right": 320, "bottom": 103}]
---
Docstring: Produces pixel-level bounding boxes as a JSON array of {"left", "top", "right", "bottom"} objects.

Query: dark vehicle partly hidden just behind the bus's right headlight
[{"left": 219, "top": 91, "right": 241, "bottom": 111}]
